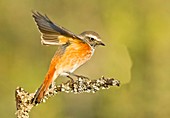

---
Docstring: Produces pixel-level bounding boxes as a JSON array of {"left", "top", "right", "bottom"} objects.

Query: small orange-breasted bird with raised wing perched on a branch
[{"left": 32, "top": 11, "right": 105, "bottom": 104}]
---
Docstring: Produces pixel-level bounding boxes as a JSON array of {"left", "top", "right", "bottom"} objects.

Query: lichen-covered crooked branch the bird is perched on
[{"left": 15, "top": 76, "right": 120, "bottom": 118}]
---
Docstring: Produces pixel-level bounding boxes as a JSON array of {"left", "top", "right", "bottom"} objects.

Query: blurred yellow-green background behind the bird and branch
[{"left": 0, "top": 0, "right": 170, "bottom": 118}]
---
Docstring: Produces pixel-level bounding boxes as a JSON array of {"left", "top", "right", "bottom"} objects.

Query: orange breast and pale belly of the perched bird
[{"left": 55, "top": 42, "right": 93, "bottom": 74}]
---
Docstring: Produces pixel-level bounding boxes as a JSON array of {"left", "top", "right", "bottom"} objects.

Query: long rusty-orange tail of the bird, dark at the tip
[{"left": 32, "top": 68, "right": 57, "bottom": 104}]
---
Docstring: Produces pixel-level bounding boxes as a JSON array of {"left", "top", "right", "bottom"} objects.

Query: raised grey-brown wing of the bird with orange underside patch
[{"left": 32, "top": 12, "right": 83, "bottom": 45}]
